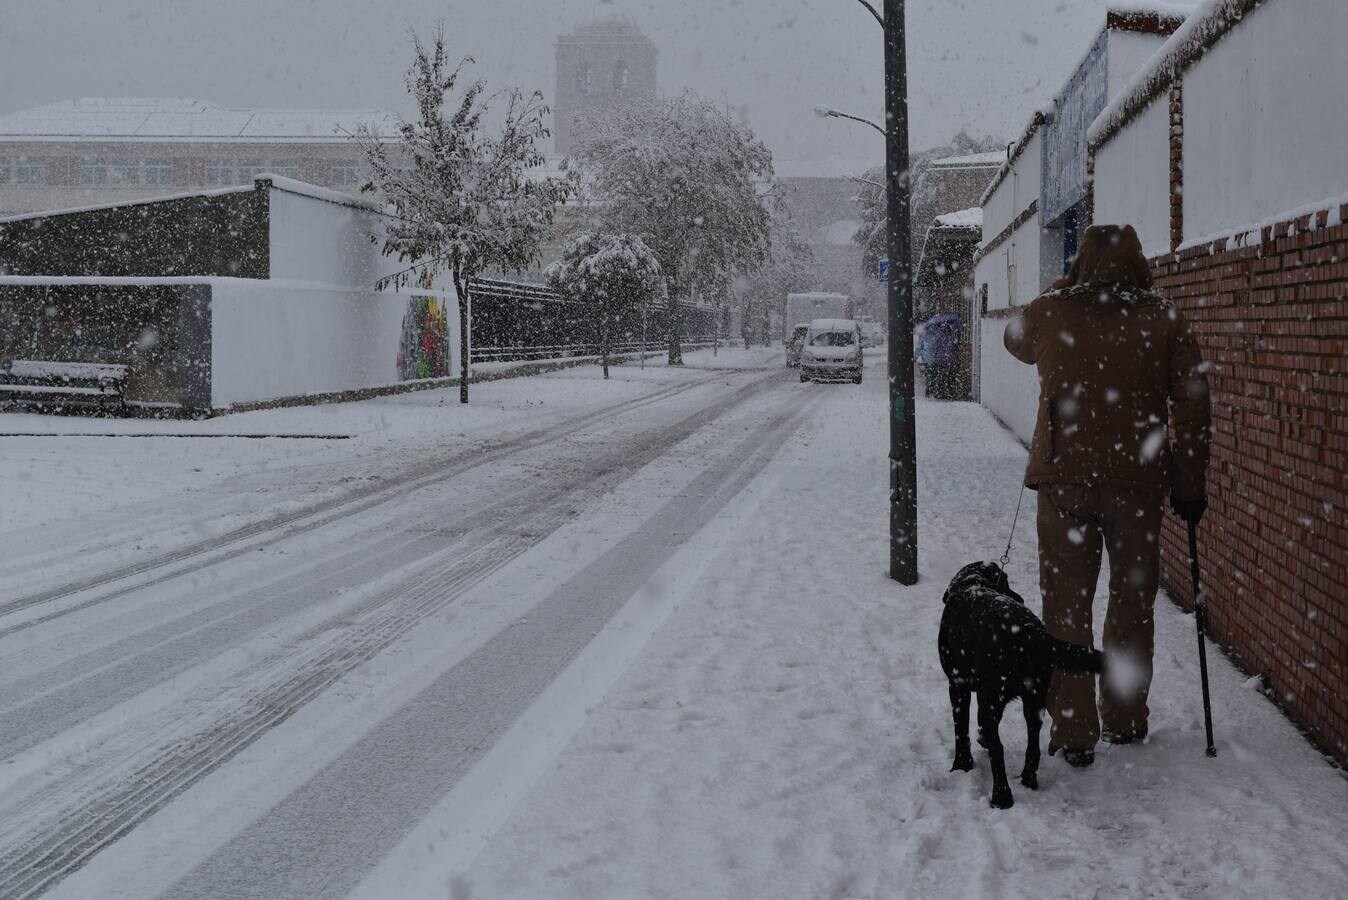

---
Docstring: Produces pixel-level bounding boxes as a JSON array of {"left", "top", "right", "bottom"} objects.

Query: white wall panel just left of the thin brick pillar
[{"left": 1095, "top": 92, "right": 1170, "bottom": 256}]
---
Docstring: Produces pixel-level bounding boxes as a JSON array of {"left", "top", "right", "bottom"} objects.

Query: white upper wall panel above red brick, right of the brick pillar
[{"left": 1184, "top": 0, "right": 1348, "bottom": 241}]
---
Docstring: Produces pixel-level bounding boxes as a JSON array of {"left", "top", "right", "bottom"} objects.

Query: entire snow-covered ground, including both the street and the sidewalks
[{"left": 0, "top": 350, "right": 1348, "bottom": 900}]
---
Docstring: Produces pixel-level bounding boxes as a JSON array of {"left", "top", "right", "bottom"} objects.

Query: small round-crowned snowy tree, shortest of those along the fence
[{"left": 547, "top": 232, "right": 662, "bottom": 379}]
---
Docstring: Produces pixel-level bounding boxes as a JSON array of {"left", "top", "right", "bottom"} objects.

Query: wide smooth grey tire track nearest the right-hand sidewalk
[{"left": 160, "top": 382, "right": 825, "bottom": 900}]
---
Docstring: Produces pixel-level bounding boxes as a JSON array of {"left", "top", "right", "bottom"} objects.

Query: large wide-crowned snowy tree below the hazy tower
[{"left": 565, "top": 93, "right": 778, "bottom": 365}]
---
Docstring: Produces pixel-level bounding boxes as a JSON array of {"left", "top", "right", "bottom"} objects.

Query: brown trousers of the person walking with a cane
[{"left": 1038, "top": 484, "right": 1165, "bottom": 749}]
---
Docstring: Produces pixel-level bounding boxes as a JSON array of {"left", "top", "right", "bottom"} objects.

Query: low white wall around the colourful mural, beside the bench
[{"left": 210, "top": 279, "right": 458, "bottom": 408}]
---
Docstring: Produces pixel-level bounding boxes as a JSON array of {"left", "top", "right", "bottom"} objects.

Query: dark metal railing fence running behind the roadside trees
[{"left": 468, "top": 279, "right": 714, "bottom": 362}]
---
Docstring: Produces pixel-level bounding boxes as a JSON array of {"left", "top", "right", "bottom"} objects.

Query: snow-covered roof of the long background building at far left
[{"left": 0, "top": 97, "right": 396, "bottom": 141}]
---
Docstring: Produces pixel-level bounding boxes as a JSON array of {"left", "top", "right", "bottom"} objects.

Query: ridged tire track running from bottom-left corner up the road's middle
[{"left": 0, "top": 372, "right": 785, "bottom": 900}]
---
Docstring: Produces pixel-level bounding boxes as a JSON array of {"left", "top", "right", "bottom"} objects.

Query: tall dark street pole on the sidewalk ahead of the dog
[{"left": 884, "top": 0, "right": 918, "bottom": 585}]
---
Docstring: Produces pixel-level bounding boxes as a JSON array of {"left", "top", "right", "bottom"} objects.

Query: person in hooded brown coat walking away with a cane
[{"left": 1004, "top": 225, "right": 1211, "bottom": 767}]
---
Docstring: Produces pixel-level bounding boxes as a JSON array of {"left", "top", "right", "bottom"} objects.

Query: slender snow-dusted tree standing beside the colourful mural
[{"left": 355, "top": 28, "right": 570, "bottom": 403}]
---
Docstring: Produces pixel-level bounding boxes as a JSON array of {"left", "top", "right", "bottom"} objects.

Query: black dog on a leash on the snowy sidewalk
[{"left": 940, "top": 563, "right": 1104, "bottom": 810}]
